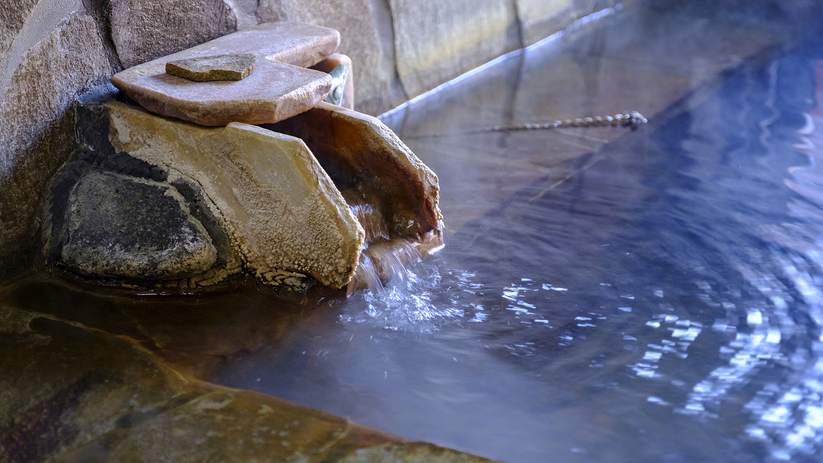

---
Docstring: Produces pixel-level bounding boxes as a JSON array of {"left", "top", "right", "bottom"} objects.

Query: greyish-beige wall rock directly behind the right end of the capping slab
[{"left": 257, "top": 0, "right": 406, "bottom": 115}]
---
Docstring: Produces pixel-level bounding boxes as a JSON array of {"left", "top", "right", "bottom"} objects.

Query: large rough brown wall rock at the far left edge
[{"left": 0, "top": 10, "right": 117, "bottom": 277}]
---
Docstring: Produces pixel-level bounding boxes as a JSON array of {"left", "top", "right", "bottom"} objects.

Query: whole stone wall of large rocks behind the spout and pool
[{"left": 0, "top": 0, "right": 618, "bottom": 278}]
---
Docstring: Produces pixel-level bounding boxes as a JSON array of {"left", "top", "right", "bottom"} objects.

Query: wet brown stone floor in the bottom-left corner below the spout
[{"left": 0, "top": 278, "right": 487, "bottom": 463}]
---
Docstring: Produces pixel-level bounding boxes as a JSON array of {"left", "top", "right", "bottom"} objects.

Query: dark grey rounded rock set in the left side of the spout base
[{"left": 62, "top": 171, "right": 217, "bottom": 280}]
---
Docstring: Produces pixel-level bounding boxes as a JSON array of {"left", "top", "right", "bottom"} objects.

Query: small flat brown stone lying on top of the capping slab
[{"left": 166, "top": 54, "right": 255, "bottom": 82}]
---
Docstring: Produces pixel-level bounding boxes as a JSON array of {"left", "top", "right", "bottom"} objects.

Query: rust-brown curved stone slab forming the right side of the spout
[{"left": 267, "top": 102, "right": 442, "bottom": 238}]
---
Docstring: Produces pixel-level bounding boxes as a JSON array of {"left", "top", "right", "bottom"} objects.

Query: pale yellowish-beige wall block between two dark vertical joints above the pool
[{"left": 389, "top": 0, "right": 520, "bottom": 98}]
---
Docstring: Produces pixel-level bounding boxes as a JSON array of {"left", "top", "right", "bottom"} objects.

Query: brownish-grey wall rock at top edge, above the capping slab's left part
[{"left": 108, "top": 0, "right": 237, "bottom": 68}]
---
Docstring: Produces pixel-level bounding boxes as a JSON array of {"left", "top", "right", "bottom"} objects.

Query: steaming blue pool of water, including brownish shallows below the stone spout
[{"left": 0, "top": 0, "right": 823, "bottom": 463}]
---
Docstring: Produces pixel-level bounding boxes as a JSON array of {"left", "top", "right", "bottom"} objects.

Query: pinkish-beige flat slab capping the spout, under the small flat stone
[{"left": 111, "top": 22, "right": 340, "bottom": 126}]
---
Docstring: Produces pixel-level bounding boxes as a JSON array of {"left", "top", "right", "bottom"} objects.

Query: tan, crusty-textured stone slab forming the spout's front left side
[{"left": 106, "top": 103, "right": 364, "bottom": 288}]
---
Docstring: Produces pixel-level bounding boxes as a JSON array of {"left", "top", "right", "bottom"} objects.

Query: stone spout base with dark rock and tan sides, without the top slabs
[{"left": 44, "top": 101, "right": 441, "bottom": 290}]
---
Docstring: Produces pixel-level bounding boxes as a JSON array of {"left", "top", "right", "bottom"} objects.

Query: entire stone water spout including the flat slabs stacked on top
[{"left": 43, "top": 23, "right": 442, "bottom": 290}]
